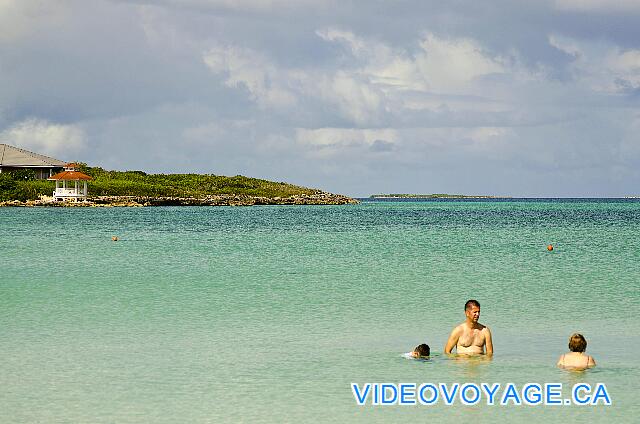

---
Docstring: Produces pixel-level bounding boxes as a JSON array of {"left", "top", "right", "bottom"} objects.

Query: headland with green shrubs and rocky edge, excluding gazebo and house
[{"left": 0, "top": 163, "right": 358, "bottom": 206}]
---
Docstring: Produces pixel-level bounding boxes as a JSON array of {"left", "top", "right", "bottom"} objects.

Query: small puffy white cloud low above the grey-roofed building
[{"left": 0, "top": 119, "right": 86, "bottom": 157}]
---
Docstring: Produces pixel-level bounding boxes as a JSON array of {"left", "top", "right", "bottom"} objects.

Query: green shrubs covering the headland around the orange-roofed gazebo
[{"left": 0, "top": 164, "right": 356, "bottom": 203}]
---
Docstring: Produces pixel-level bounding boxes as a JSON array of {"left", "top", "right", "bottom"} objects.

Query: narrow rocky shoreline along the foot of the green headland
[{"left": 0, "top": 192, "right": 359, "bottom": 207}]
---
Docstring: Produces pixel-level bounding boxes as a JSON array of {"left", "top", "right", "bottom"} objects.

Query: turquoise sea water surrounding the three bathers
[{"left": 0, "top": 200, "right": 640, "bottom": 423}]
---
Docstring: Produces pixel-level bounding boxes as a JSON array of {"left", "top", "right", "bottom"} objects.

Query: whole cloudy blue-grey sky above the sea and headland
[{"left": 0, "top": 0, "right": 640, "bottom": 197}]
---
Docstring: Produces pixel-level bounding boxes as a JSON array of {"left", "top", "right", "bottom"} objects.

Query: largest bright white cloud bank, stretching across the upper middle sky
[{"left": 203, "top": 28, "right": 527, "bottom": 127}]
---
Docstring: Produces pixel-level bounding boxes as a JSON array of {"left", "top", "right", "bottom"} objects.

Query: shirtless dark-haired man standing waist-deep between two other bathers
[{"left": 444, "top": 299, "right": 493, "bottom": 355}]
